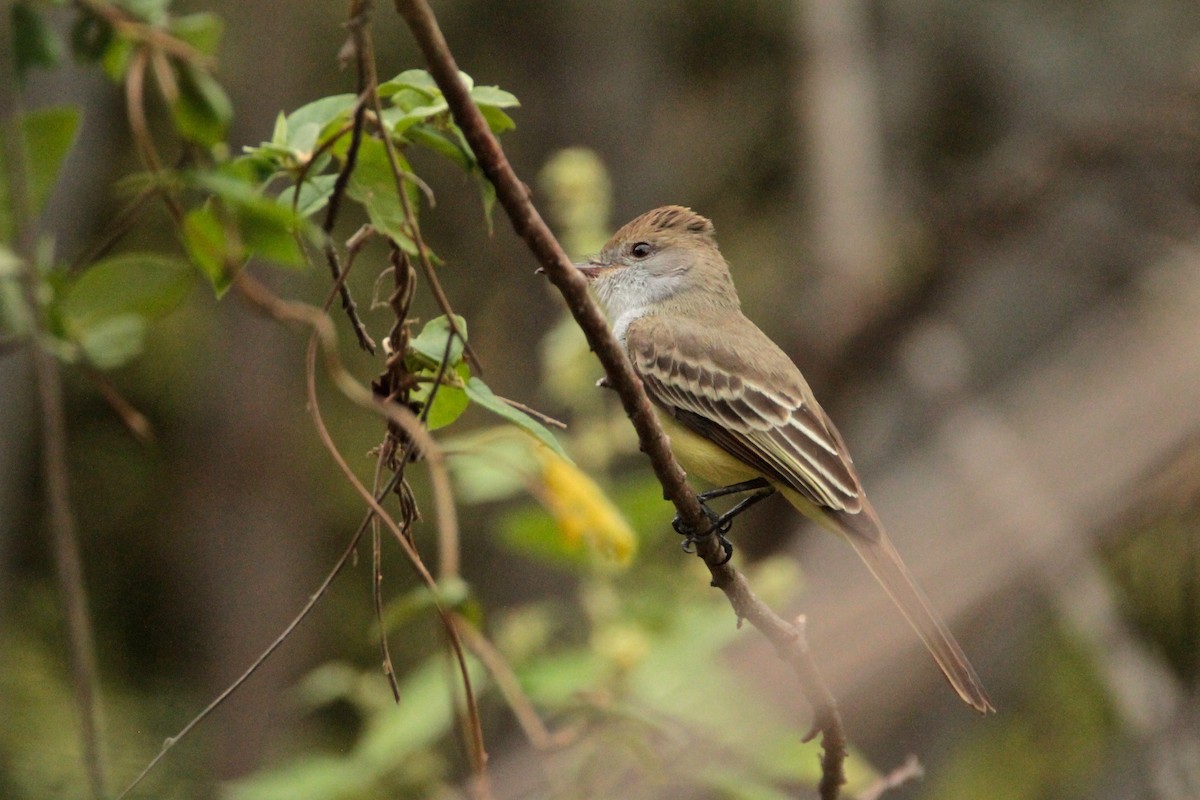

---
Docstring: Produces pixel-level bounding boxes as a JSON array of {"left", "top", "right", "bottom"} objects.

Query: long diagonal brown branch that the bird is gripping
[{"left": 394, "top": 0, "right": 846, "bottom": 800}]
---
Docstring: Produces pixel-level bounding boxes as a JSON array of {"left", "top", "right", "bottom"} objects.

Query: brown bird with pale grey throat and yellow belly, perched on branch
[{"left": 575, "top": 205, "right": 995, "bottom": 714}]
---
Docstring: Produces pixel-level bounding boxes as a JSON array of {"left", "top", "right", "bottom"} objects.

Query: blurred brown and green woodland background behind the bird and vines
[{"left": 7, "top": 0, "right": 1200, "bottom": 800}]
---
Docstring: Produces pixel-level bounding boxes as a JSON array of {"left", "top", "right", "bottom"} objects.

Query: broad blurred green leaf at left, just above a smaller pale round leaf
[{"left": 59, "top": 253, "right": 192, "bottom": 331}]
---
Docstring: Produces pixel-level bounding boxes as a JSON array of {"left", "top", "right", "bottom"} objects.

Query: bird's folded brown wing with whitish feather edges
[{"left": 625, "top": 317, "right": 863, "bottom": 513}]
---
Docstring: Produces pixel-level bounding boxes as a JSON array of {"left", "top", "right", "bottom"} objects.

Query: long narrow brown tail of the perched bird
[{"left": 830, "top": 499, "right": 996, "bottom": 714}]
